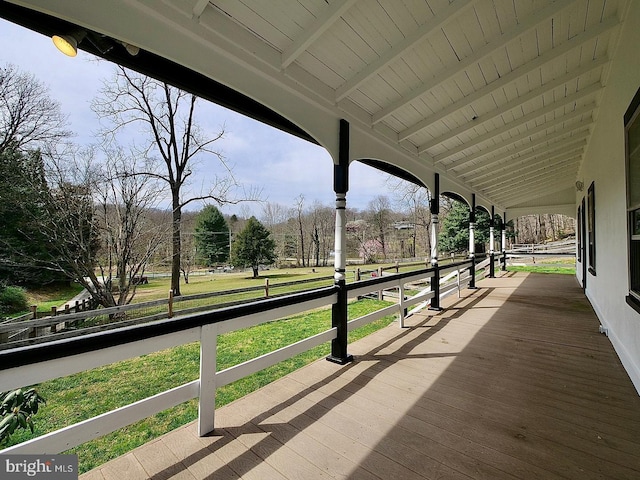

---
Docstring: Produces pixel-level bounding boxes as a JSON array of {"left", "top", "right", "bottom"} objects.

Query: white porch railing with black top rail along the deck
[{"left": 0, "top": 261, "right": 470, "bottom": 454}]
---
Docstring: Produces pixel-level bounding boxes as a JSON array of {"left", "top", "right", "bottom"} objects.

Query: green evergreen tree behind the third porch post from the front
[{"left": 438, "top": 201, "right": 490, "bottom": 253}]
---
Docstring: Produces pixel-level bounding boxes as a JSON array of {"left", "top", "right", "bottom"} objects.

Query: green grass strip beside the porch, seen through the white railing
[{"left": 5, "top": 300, "right": 394, "bottom": 472}]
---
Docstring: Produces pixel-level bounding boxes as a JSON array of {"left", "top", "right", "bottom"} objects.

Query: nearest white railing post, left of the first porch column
[{"left": 198, "top": 323, "right": 218, "bottom": 437}]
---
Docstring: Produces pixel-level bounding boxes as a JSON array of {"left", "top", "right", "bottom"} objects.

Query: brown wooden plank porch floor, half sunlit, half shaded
[{"left": 82, "top": 273, "right": 640, "bottom": 480}]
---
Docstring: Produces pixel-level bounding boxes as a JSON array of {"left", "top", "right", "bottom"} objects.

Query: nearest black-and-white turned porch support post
[{"left": 327, "top": 120, "right": 353, "bottom": 365}]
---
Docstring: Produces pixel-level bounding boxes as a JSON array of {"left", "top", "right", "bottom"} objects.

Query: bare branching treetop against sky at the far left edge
[{"left": 0, "top": 64, "right": 71, "bottom": 156}]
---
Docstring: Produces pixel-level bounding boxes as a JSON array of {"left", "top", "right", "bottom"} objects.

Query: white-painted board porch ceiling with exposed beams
[{"left": 7, "top": 0, "right": 628, "bottom": 214}]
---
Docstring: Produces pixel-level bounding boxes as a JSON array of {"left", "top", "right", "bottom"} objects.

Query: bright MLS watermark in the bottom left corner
[{"left": 0, "top": 455, "right": 78, "bottom": 480}]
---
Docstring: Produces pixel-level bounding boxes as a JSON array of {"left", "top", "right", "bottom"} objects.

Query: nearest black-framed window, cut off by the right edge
[{"left": 624, "top": 90, "right": 640, "bottom": 309}]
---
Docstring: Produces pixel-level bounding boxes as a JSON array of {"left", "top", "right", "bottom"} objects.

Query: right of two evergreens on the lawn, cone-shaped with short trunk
[{"left": 231, "top": 217, "right": 277, "bottom": 278}]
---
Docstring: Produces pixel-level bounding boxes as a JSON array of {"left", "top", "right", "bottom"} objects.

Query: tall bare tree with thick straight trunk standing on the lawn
[{"left": 92, "top": 67, "right": 248, "bottom": 295}]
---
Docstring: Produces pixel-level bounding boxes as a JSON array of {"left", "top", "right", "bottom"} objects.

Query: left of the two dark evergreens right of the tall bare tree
[{"left": 195, "top": 205, "right": 231, "bottom": 267}]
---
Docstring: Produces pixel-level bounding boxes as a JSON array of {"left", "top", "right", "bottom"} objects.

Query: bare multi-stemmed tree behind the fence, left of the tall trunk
[{"left": 40, "top": 149, "right": 163, "bottom": 307}]
